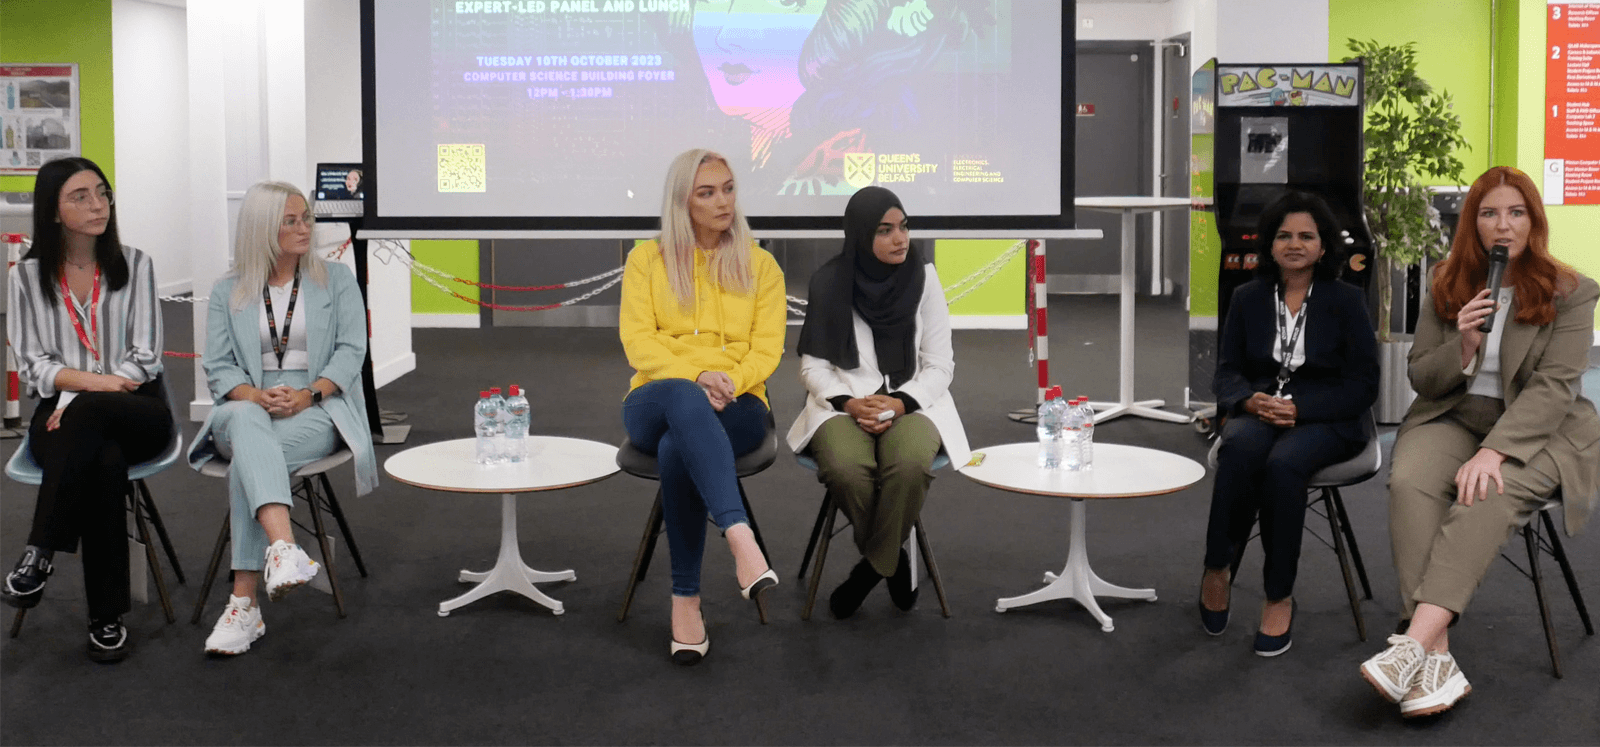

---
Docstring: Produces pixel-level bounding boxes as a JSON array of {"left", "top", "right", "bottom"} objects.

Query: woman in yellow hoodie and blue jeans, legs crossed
[{"left": 621, "top": 150, "right": 787, "bottom": 665}]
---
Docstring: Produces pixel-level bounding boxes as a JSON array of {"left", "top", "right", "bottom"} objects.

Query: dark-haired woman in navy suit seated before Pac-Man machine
[{"left": 1200, "top": 192, "right": 1378, "bottom": 656}]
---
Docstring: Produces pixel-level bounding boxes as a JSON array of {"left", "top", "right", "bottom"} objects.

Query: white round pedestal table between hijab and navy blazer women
[{"left": 960, "top": 443, "right": 1205, "bottom": 633}]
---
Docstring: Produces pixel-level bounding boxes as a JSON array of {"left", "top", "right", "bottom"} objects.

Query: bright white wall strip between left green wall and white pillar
[{"left": 110, "top": 0, "right": 189, "bottom": 294}]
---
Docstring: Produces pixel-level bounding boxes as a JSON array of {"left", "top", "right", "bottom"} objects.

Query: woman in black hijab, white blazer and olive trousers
[{"left": 789, "top": 187, "right": 970, "bottom": 617}]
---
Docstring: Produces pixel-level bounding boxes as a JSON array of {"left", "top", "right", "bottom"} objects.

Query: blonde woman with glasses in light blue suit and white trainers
[{"left": 189, "top": 182, "right": 378, "bottom": 654}]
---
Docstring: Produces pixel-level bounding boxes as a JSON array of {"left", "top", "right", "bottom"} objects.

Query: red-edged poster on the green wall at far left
[{"left": 0, "top": 62, "right": 83, "bottom": 174}]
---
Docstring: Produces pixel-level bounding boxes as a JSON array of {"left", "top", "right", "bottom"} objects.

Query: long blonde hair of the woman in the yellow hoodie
[{"left": 656, "top": 149, "right": 755, "bottom": 307}]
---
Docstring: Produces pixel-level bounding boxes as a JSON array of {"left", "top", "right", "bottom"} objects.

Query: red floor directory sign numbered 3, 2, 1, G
[{"left": 1544, "top": 0, "right": 1600, "bottom": 205}]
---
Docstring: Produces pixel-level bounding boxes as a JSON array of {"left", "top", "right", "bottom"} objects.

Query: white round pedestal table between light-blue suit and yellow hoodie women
[{"left": 384, "top": 435, "right": 618, "bottom": 617}]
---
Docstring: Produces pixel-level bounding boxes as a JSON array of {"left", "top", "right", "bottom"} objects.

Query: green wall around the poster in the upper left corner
[{"left": 0, "top": 0, "right": 117, "bottom": 192}]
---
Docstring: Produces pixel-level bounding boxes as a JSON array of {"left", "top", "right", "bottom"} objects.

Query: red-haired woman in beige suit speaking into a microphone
[{"left": 1362, "top": 166, "right": 1600, "bottom": 717}]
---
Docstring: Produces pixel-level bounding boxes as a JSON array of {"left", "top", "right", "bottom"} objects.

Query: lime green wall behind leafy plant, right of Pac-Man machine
[{"left": 1324, "top": 0, "right": 1484, "bottom": 184}]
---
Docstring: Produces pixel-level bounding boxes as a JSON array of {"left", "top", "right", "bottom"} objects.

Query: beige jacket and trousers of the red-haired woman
[{"left": 1389, "top": 277, "right": 1600, "bottom": 617}]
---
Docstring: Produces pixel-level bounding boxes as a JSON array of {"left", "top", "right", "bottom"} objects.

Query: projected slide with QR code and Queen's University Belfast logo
[{"left": 368, "top": 0, "right": 1070, "bottom": 222}]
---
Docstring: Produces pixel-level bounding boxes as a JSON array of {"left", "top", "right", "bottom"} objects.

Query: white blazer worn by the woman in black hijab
[{"left": 789, "top": 264, "right": 971, "bottom": 469}]
